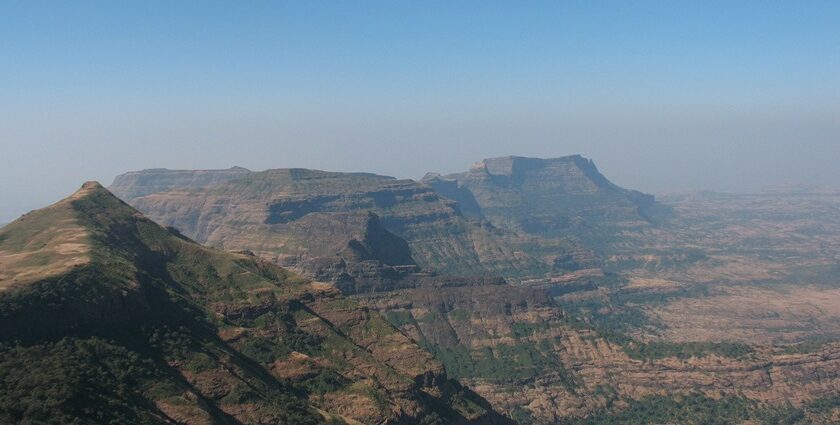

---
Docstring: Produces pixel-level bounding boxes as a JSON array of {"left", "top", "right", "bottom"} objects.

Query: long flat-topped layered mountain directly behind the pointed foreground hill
[{"left": 112, "top": 169, "right": 588, "bottom": 275}]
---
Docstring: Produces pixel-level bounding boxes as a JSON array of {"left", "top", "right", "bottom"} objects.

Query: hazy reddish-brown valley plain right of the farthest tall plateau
[{"left": 592, "top": 190, "right": 840, "bottom": 346}]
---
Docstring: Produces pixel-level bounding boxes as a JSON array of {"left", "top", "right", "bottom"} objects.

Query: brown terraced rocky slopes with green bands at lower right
[{"left": 355, "top": 270, "right": 840, "bottom": 424}]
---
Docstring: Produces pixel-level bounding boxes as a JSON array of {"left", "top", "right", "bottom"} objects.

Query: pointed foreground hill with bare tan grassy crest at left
[{"left": 0, "top": 182, "right": 506, "bottom": 424}]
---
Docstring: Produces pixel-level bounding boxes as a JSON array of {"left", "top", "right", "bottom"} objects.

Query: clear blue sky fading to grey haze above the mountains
[{"left": 0, "top": 0, "right": 840, "bottom": 222}]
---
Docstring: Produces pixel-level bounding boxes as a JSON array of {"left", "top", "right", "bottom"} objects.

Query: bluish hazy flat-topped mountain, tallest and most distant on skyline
[{"left": 423, "top": 155, "right": 654, "bottom": 246}]
